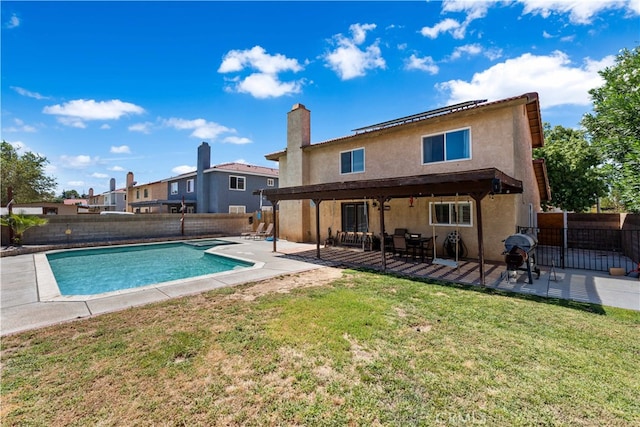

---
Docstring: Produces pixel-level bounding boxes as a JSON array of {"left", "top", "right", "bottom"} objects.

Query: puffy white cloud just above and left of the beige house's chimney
[{"left": 218, "top": 46, "right": 304, "bottom": 99}]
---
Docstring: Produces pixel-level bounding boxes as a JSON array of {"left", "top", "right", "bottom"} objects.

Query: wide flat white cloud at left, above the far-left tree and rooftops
[{"left": 42, "top": 99, "right": 144, "bottom": 128}]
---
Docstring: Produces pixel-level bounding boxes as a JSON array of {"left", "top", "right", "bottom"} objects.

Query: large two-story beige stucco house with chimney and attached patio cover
[{"left": 263, "top": 93, "right": 550, "bottom": 280}]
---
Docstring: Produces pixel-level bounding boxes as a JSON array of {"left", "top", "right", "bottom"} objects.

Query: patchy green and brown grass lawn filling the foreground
[{"left": 0, "top": 268, "right": 640, "bottom": 426}]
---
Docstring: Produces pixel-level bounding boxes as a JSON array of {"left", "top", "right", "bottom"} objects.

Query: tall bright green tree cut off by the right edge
[{"left": 582, "top": 46, "right": 640, "bottom": 212}]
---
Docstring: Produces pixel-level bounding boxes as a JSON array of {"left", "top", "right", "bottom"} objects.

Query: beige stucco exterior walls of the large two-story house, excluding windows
[{"left": 272, "top": 100, "right": 540, "bottom": 261}]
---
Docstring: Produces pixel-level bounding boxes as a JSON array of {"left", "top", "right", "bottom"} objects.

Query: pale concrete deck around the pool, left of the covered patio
[{"left": 0, "top": 237, "right": 324, "bottom": 335}]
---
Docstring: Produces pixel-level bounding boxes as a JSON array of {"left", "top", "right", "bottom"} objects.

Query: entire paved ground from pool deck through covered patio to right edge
[{"left": 0, "top": 237, "right": 640, "bottom": 335}]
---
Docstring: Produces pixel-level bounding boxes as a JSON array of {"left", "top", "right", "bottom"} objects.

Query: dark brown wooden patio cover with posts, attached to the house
[{"left": 253, "top": 168, "right": 523, "bottom": 285}]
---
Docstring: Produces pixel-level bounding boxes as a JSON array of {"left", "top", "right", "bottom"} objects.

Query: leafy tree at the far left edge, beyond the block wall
[{"left": 0, "top": 141, "right": 56, "bottom": 205}]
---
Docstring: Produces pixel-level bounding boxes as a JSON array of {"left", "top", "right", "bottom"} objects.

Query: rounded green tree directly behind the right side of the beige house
[{"left": 534, "top": 123, "right": 607, "bottom": 212}]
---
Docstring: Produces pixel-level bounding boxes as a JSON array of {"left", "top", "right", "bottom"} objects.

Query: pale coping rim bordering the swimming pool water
[{"left": 33, "top": 238, "right": 265, "bottom": 302}]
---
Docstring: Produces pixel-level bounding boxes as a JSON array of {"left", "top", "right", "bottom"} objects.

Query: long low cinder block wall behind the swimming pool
[{"left": 12, "top": 214, "right": 252, "bottom": 245}]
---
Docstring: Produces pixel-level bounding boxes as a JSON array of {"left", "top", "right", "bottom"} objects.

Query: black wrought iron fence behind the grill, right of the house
[{"left": 517, "top": 227, "right": 640, "bottom": 272}]
